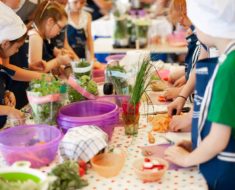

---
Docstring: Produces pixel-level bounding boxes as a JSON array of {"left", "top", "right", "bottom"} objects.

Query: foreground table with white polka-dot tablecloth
[{"left": 0, "top": 113, "right": 207, "bottom": 190}]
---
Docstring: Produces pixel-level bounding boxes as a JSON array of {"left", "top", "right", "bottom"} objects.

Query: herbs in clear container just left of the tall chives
[{"left": 106, "top": 62, "right": 129, "bottom": 94}]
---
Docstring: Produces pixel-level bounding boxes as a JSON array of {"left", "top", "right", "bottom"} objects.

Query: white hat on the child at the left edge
[{"left": 0, "top": 2, "right": 27, "bottom": 44}]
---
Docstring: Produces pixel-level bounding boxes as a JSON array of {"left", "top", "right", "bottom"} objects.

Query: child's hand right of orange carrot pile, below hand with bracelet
[{"left": 169, "top": 114, "right": 192, "bottom": 132}]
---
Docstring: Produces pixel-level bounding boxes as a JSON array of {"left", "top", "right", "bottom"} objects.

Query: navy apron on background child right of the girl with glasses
[{"left": 67, "top": 24, "right": 87, "bottom": 58}]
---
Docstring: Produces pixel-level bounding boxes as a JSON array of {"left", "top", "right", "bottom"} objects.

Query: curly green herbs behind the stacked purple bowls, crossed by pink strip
[{"left": 68, "top": 75, "right": 98, "bottom": 102}]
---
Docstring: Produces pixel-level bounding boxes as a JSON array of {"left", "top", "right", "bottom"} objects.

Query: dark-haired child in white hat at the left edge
[{"left": 0, "top": 2, "right": 26, "bottom": 128}]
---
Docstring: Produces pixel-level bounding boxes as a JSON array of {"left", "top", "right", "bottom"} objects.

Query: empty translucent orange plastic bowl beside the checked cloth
[{"left": 91, "top": 151, "right": 125, "bottom": 178}]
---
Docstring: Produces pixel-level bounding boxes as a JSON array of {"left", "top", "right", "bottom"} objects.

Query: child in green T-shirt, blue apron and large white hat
[{"left": 165, "top": 0, "right": 235, "bottom": 190}]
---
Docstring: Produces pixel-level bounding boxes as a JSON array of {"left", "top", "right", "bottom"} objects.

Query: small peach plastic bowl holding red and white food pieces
[{"left": 133, "top": 157, "right": 169, "bottom": 182}]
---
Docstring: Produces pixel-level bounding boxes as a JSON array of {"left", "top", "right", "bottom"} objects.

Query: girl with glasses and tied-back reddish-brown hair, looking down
[{"left": 28, "top": 1, "right": 72, "bottom": 72}]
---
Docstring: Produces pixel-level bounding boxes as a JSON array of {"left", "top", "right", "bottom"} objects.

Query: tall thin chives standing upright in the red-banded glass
[{"left": 130, "top": 57, "right": 153, "bottom": 105}]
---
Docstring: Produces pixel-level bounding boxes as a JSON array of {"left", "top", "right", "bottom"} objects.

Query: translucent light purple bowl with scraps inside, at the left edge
[{"left": 0, "top": 125, "right": 62, "bottom": 168}]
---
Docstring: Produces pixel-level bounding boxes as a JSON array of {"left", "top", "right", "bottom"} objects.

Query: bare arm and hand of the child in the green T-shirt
[{"left": 165, "top": 123, "right": 231, "bottom": 167}]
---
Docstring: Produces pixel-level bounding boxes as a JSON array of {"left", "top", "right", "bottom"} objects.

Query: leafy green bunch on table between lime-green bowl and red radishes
[{"left": 48, "top": 161, "right": 88, "bottom": 190}]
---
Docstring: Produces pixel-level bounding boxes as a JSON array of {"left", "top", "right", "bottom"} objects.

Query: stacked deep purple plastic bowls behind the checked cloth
[{"left": 57, "top": 100, "right": 119, "bottom": 139}]
